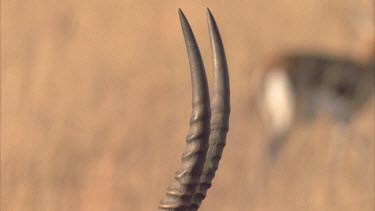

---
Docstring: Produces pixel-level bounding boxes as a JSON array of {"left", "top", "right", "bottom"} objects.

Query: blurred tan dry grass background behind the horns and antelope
[{"left": 1, "top": 0, "right": 374, "bottom": 211}]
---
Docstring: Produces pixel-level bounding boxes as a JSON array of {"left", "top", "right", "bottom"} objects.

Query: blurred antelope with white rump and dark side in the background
[{"left": 257, "top": 23, "right": 375, "bottom": 161}]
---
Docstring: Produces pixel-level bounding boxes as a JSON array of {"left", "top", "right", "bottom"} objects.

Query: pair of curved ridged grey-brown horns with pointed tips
[{"left": 159, "top": 9, "right": 230, "bottom": 211}]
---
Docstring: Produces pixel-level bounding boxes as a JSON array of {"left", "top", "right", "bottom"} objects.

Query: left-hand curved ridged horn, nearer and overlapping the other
[{"left": 159, "top": 9, "right": 210, "bottom": 210}]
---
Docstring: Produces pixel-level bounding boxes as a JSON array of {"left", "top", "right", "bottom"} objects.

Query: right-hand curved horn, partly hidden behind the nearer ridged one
[{"left": 192, "top": 9, "right": 230, "bottom": 210}]
